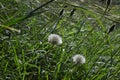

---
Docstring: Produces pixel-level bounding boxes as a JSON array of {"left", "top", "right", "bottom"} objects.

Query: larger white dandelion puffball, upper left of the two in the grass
[{"left": 48, "top": 34, "right": 62, "bottom": 45}]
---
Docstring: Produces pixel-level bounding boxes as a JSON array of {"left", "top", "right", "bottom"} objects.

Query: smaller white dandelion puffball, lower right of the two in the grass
[{"left": 72, "top": 54, "right": 86, "bottom": 64}]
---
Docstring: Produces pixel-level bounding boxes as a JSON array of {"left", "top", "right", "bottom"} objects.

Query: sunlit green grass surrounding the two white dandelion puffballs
[{"left": 0, "top": 0, "right": 120, "bottom": 80}]
